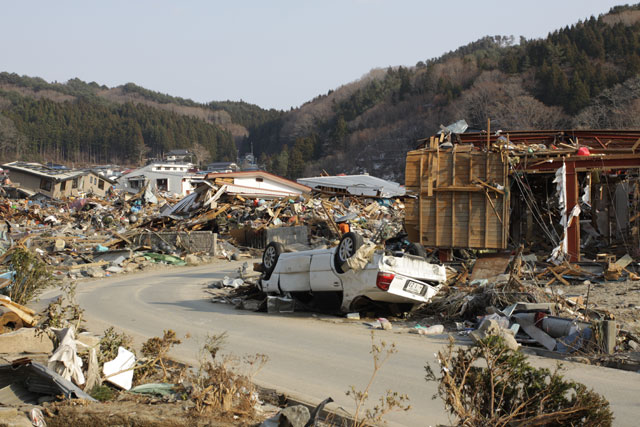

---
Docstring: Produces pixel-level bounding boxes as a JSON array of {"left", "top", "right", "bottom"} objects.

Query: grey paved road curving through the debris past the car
[{"left": 53, "top": 263, "right": 640, "bottom": 426}]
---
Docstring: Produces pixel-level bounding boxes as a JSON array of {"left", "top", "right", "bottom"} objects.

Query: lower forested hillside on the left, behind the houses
[{"left": 0, "top": 72, "right": 276, "bottom": 166}]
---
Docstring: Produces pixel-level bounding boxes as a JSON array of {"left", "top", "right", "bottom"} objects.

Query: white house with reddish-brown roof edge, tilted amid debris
[{"left": 206, "top": 171, "right": 311, "bottom": 199}]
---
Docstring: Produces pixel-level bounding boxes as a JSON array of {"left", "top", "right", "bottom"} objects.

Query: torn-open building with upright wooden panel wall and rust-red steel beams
[{"left": 405, "top": 130, "right": 640, "bottom": 262}]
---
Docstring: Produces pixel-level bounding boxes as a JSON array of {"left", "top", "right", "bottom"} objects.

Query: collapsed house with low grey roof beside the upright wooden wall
[{"left": 298, "top": 174, "right": 405, "bottom": 198}]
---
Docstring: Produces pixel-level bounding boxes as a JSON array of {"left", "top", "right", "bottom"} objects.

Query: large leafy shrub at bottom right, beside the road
[{"left": 425, "top": 336, "right": 613, "bottom": 426}]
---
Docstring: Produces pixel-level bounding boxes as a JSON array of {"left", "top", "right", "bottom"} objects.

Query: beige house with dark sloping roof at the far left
[{"left": 3, "top": 162, "right": 114, "bottom": 199}]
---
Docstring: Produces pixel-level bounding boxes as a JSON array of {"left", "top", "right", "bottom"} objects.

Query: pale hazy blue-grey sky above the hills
[{"left": 0, "top": 0, "right": 624, "bottom": 109}]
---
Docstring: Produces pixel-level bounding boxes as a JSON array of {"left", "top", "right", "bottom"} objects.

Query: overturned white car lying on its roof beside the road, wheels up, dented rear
[{"left": 260, "top": 232, "right": 446, "bottom": 312}]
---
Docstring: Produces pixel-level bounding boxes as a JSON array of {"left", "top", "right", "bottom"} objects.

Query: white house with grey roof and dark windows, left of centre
[{"left": 116, "top": 162, "right": 202, "bottom": 196}]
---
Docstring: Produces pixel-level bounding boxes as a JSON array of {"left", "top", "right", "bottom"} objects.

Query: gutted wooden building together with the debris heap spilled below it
[{"left": 405, "top": 128, "right": 640, "bottom": 364}]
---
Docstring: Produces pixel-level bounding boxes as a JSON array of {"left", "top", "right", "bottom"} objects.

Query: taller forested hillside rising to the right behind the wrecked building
[{"left": 249, "top": 5, "right": 640, "bottom": 181}]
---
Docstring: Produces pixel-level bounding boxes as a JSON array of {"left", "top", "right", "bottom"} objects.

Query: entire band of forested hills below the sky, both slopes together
[{"left": 0, "top": 5, "right": 640, "bottom": 175}]
